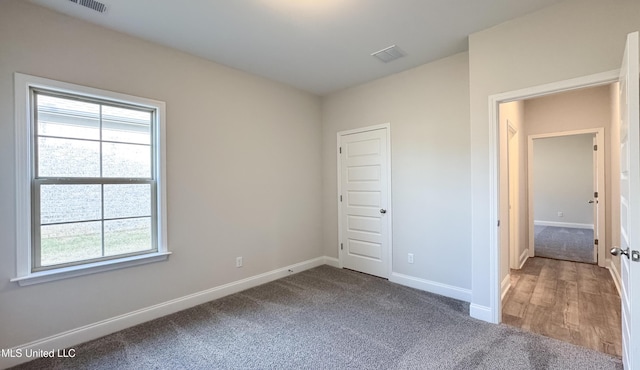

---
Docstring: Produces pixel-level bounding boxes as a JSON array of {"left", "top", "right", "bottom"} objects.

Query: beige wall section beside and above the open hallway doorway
[{"left": 469, "top": 0, "right": 640, "bottom": 317}]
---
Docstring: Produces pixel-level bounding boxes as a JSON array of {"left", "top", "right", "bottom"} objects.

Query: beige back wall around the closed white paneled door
[{"left": 322, "top": 53, "right": 471, "bottom": 299}]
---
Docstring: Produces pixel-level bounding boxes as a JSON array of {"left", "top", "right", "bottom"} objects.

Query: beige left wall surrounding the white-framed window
[{"left": 0, "top": 0, "right": 322, "bottom": 348}]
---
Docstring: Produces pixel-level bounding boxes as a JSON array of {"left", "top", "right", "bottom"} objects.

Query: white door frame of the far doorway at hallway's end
[{"left": 527, "top": 127, "right": 607, "bottom": 267}]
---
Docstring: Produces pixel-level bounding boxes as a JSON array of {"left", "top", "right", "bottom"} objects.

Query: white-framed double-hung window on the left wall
[{"left": 12, "top": 74, "right": 168, "bottom": 285}]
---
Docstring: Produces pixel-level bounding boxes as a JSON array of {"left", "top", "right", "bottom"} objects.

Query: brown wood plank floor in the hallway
[{"left": 502, "top": 257, "right": 622, "bottom": 357}]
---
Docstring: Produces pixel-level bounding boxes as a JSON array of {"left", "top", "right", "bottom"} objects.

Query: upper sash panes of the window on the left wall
[{"left": 33, "top": 90, "right": 155, "bottom": 178}]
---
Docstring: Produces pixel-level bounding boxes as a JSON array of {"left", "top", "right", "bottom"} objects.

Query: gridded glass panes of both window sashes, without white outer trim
[{"left": 32, "top": 89, "right": 158, "bottom": 271}]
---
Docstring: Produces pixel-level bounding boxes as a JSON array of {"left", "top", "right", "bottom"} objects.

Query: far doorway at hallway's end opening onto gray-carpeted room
[{"left": 527, "top": 132, "right": 600, "bottom": 266}]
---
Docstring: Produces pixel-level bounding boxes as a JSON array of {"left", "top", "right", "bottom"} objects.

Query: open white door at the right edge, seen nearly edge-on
[{"left": 612, "top": 32, "right": 640, "bottom": 369}]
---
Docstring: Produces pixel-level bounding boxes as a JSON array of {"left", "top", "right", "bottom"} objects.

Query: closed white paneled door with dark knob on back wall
[{"left": 339, "top": 127, "right": 391, "bottom": 278}]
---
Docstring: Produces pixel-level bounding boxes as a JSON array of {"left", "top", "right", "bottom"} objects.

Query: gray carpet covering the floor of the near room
[{"left": 11, "top": 266, "right": 622, "bottom": 370}]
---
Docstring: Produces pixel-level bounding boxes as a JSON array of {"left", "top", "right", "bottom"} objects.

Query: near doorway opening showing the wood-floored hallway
[{"left": 497, "top": 83, "right": 622, "bottom": 356}]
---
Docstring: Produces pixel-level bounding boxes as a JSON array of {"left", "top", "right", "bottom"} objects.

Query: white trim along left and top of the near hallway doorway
[{"left": 487, "top": 69, "right": 620, "bottom": 324}]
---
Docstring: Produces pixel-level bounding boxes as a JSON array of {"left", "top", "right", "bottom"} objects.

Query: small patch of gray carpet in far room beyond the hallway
[{"left": 534, "top": 226, "right": 596, "bottom": 263}]
